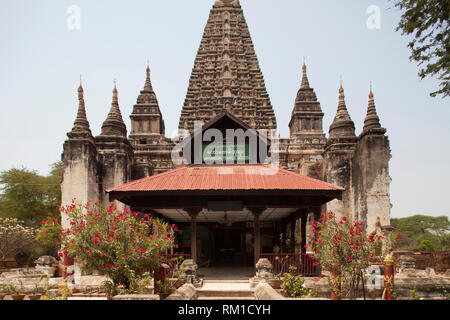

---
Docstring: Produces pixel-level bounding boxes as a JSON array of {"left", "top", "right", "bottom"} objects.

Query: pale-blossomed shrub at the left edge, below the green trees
[{"left": 0, "top": 218, "right": 34, "bottom": 261}]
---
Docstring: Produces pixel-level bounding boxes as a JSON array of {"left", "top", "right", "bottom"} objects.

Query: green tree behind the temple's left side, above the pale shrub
[{"left": 0, "top": 162, "right": 62, "bottom": 226}]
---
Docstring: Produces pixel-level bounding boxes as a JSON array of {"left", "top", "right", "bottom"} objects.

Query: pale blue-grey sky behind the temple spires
[{"left": 0, "top": 0, "right": 450, "bottom": 217}]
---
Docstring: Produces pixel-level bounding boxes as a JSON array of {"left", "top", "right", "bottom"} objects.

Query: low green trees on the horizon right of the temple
[{"left": 391, "top": 215, "right": 450, "bottom": 250}]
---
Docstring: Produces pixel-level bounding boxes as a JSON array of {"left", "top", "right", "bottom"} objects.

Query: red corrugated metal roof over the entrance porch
[{"left": 108, "top": 164, "right": 345, "bottom": 192}]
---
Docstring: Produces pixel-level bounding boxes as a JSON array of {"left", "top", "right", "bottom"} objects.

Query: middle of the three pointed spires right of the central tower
[{"left": 329, "top": 78, "right": 355, "bottom": 138}]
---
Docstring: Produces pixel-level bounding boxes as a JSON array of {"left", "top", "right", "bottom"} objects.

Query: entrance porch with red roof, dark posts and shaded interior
[{"left": 109, "top": 164, "right": 344, "bottom": 275}]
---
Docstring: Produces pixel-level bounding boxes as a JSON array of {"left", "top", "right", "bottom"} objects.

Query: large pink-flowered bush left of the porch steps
[{"left": 60, "top": 202, "right": 177, "bottom": 289}]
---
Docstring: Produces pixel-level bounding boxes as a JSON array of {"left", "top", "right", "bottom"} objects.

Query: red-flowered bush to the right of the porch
[{"left": 312, "top": 212, "right": 382, "bottom": 298}]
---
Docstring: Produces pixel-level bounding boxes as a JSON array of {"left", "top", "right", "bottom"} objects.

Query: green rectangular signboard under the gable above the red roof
[{"left": 202, "top": 143, "right": 251, "bottom": 163}]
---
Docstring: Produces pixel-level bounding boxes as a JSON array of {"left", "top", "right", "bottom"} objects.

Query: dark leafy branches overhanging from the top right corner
[{"left": 394, "top": 0, "right": 450, "bottom": 98}]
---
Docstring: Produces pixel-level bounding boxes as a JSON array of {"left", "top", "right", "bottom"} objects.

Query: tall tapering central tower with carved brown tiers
[{"left": 179, "top": 0, "right": 276, "bottom": 132}]
